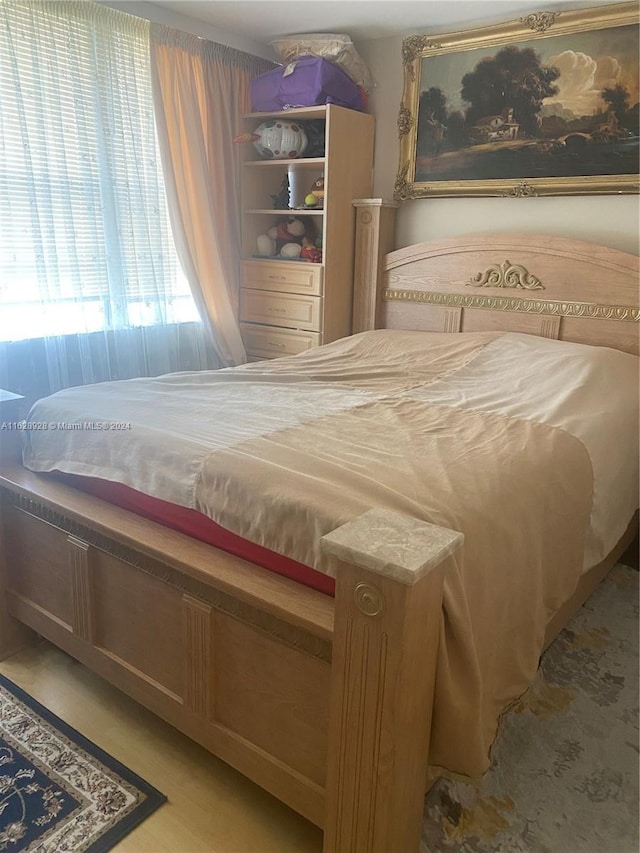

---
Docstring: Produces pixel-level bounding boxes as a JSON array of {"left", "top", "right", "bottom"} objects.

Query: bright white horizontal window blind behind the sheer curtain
[{"left": 0, "top": 0, "right": 197, "bottom": 340}]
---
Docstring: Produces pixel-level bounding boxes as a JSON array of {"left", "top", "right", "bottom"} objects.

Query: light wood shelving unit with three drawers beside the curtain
[{"left": 239, "top": 104, "right": 374, "bottom": 359}]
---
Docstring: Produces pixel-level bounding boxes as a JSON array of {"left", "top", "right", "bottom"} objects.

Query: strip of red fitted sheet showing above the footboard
[{"left": 57, "top": 473, "right": 335, "bottom": 595}]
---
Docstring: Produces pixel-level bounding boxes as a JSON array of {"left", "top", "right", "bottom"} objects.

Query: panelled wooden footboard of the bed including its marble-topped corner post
[{"left": 0, "top": 466, "right": 462, "bottom": 853}]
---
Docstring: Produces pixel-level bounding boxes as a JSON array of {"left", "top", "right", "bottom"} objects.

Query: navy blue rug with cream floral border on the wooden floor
[{"left": 0, "top": 676, "right": 166, "bottom": 853}]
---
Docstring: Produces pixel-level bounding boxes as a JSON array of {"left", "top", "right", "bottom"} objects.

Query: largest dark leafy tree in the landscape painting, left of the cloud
[{"left": 461, "top": 45, "right": 560, "bottom": 137}]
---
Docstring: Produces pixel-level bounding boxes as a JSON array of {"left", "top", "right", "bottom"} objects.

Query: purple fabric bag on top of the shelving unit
[{"left": 250, "top": 56, "right": 365, "bottom": 112}]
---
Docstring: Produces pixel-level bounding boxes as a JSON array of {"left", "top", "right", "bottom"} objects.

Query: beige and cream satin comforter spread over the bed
[{"left": 24, "top": 331, "right": 637, "bottom": 775}]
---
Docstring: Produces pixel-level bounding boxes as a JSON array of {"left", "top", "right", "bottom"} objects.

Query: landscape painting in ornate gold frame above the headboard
[{"left": 394, "top": 2, "right": 640, "bottom": 200}]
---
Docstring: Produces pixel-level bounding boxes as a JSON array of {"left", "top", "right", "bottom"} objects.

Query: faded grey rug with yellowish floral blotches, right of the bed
[{"left": 421, "top": 565, "right": 639, "bottom": 853}]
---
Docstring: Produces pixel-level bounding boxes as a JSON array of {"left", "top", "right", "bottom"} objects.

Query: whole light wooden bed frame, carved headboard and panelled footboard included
[{"left": 0, "top": 208, "right": 640, "bottom": 853}]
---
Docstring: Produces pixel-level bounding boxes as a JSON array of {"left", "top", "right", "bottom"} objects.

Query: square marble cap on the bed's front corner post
[{"left": 320, "top": 508, "right": 464, "bottom": 585}]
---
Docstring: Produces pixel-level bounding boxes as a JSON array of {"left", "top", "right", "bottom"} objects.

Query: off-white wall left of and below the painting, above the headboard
[{"left": 357, "top": 37, "right": 640, "bottom": 254}]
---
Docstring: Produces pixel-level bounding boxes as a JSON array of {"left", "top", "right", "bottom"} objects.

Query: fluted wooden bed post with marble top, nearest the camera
[{"left": 321, "top": 509, "right": 463, "bottom": 853}]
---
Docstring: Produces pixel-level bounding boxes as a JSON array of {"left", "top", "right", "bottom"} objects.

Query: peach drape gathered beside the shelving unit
[{"left": 150, "top": 24, "right": 273, "bottom": 365}]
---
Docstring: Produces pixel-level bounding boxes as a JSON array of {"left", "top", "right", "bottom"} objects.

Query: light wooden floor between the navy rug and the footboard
[{"left": 0, "top": 641, "right": 322, "bottom": 853}]
